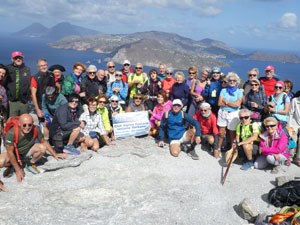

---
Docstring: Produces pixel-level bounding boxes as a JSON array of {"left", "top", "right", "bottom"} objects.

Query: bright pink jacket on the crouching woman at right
[{"left": 259, "top": 123, "right": 290, "bottom": 159}]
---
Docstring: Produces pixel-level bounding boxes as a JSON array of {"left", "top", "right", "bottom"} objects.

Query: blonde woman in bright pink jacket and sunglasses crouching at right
[{"left": 254, "top": 117, "right": 290, "bottom": 173}]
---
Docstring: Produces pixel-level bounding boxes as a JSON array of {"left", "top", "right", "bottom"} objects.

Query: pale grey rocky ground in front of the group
[{"left": 0, "top": 137, "right": 300, "bottom": 225}]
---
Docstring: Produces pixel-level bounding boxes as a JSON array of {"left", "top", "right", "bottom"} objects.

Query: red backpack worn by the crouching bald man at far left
[{"left": 3, "top": 116, "right": 37, "bottom": 166}]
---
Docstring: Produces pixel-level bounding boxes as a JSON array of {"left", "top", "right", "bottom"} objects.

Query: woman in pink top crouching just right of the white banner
[{"left": 148, "top": 91, "right": 172, "bottom": 136}]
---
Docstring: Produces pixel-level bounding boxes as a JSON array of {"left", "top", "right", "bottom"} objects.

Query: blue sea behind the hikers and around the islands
[{"left": 0, "top": 34, "right": 300, "bottom": 92}]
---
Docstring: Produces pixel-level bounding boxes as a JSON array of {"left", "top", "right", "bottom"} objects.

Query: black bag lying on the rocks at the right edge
[{"left": 268, "top": 180, "right": 300, "bottom": 207}]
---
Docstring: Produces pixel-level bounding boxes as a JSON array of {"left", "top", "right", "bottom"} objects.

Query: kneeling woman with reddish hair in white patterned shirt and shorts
[{"left": 79, "top": 96, "right": 111, "bottom": 151}]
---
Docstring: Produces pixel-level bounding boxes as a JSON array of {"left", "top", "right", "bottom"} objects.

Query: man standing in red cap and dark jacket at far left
[{"left": 5, "top": 51, "right": 31, "bottom": 117}]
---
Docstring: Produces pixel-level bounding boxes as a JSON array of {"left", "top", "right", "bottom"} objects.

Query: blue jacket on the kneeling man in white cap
[{"left": 159, "top": 110, "right": 201, "bottom": 141}]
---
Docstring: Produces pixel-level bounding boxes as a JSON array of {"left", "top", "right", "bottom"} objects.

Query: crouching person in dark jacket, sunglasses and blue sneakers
[{"left": 50, "top": 93, "right": 84, "bottom": 155}]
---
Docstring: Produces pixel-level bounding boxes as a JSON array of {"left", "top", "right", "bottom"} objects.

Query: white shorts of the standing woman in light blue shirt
[{"left": 217, "top": 109, "right": 240, "bottom": 131}]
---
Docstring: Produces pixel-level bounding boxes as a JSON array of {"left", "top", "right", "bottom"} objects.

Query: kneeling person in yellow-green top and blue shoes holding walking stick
[{"left": 232, "top": 109, "right": 260, "bottom": 170}]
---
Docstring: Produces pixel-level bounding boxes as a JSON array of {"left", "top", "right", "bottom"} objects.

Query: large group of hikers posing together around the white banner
[{"left": 0, "top": 51, "right": 300, "bottom": 191}]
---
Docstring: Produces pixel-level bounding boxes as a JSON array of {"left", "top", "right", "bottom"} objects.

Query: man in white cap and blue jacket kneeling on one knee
[{"left": 158, "top": 99, "right": 201, "bottom": 160}]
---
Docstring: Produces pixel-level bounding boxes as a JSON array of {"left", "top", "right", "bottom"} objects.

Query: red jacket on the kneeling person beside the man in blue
[{"left": 193, "top": 110, "right": 219, "bottom": 136}]
